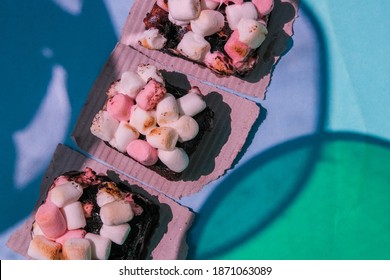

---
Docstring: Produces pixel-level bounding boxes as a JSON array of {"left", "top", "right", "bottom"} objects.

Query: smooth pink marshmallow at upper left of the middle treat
[{"left": 107, "top": 93, "right": 134, "bottom": 121}]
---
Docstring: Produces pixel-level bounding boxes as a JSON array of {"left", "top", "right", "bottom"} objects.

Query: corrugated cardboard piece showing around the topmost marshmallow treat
[{"left": 120, "top": 0, "right": 299, "bottom": 99}]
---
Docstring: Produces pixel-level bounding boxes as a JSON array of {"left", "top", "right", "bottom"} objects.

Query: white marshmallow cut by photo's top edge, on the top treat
[{"left": 168, "top": 0, "right": 200, "bottom": 21}]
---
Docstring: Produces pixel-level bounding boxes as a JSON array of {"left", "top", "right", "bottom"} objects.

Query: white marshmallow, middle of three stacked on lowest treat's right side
[{"left": 100, "top": 200, "right": 134, "bottom": 226}]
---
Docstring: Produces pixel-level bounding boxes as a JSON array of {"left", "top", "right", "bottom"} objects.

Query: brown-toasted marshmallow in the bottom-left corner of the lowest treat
[{"left": 27, "top": 235, "right": 61, "bottom": 260}]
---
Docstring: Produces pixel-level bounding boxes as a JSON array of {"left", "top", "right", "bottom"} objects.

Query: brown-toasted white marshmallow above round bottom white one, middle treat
[{"left": 146, "top": 127, "right": 179, "bottom": 151}]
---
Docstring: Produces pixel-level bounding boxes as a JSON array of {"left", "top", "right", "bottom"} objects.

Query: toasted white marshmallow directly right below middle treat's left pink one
[{"left": 129, "top": 105, "right": 157, "bottom": 135}]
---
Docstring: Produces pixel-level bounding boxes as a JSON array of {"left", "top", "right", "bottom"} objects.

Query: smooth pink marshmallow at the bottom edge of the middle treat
[{"left": 126, "top": 139, "right": 158, "bottom": 166}]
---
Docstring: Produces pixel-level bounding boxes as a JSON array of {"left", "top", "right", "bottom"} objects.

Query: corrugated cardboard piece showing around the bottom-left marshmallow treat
[{"left": 7, "top": 144, "right": 194, "bottom": 260}]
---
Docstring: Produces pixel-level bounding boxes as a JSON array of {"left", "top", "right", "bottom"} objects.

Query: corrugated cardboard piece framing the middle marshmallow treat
[{"left": 72, "top": 44, "right": 260, "bottom": 198}]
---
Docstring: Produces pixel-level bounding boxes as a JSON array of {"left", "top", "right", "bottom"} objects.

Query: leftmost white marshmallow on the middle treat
[{"left": 91, "top": 110, "right": 119, "bottom": 141}]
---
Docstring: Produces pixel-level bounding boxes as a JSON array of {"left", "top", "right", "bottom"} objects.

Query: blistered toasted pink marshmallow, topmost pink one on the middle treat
[{"left": 135, "top": 79, "right": 167, "bottom": 111}]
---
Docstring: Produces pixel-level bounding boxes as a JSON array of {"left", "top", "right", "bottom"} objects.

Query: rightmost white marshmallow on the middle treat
[{"left": 177, "top": 87, "right": 207, "bottom": 117}]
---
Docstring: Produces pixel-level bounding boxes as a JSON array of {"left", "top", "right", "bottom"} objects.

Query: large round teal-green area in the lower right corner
[{"left": 195, "top": 134, "right": 390, "bottom": 260}]
